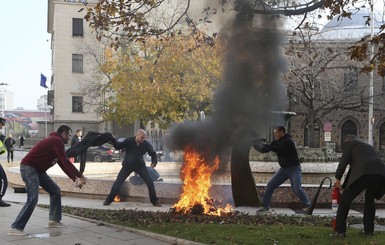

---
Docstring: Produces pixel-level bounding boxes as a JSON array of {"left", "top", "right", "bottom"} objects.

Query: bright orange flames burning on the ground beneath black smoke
[{"left": 173, "top": 147, "right": 232, "bottom": 216}]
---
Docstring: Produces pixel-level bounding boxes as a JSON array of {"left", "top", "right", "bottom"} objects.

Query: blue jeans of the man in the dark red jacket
[{"left": 11, "top": 165, "right": 62, "bottom": 230}]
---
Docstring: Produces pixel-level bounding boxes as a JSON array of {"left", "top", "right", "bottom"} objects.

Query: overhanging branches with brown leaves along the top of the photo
[{"left": 85, "top": 0, "right": 385, "bottom": 76}]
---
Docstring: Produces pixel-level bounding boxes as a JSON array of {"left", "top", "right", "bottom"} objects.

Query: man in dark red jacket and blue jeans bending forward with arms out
[{"left": 8, "top": 125, "right": 87, "bottom": 236}]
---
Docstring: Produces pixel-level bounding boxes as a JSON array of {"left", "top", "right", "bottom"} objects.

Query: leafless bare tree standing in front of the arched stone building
[{"left": 285, "top": 25, "right": 368, "bottom": 147}]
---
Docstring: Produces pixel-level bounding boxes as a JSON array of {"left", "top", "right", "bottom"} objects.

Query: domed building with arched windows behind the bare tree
[{"left": 289, "top": 9, "right": 385, "bottom": 152}]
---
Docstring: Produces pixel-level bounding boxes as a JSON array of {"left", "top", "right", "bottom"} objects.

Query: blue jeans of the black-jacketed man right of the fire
[{"left": 262, "top": 165, "right": 310, "bottom": 208}]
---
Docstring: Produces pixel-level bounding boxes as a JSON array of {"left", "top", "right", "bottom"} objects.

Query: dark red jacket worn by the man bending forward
[{"left": 21, "top": 132, "right": 82, "bottom": 181}]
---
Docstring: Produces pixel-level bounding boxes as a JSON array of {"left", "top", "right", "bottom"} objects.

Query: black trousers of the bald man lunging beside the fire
[{"left": 106, "top": 164, "right": 158, "bottom": 204}]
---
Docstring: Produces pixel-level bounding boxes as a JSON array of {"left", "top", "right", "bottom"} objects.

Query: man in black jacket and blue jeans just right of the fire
[{"left": 254, "top": 125, "right": 310, "bottom": 212}]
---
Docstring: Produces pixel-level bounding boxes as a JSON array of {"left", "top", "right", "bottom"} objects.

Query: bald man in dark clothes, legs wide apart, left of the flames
[{"left": 103, "top": 129, "right": 161, "bottom": 207}]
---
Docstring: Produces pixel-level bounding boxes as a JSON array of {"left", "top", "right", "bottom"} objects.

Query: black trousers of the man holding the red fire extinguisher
[{"left": 336, "top": 174, "right": 385, "bottom": 233}]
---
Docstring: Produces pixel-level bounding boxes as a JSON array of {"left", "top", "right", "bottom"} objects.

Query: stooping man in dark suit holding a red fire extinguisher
[{"left": 334, "top": 135, "right": 385, "bottom": 237}]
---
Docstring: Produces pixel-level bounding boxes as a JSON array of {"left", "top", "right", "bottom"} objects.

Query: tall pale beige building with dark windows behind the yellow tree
[{"left": 47, "top": 0, "right": 139, "bottom": 137}]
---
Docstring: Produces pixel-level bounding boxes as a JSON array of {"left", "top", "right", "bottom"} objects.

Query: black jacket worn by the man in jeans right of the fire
[{"left": 254, "top": 134, "right": 300, "bottom": 168}]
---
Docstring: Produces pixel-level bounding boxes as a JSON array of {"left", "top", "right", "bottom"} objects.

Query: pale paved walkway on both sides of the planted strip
[{"left": 0, "top": 188, "right": 385, "bottom": 245}]
